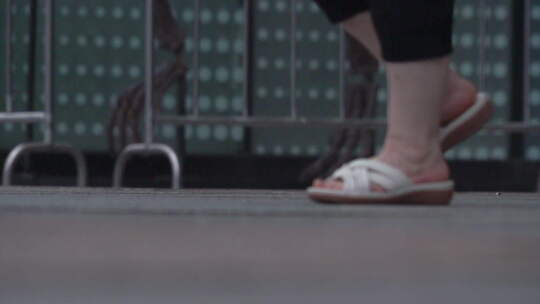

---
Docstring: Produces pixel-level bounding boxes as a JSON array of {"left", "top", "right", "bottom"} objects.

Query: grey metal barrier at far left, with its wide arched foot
[{"left": 0, "top": 0, "right": 87, "bottom": 187}]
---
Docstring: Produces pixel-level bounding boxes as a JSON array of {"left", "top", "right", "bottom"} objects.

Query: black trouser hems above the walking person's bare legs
[{"left": 314, "top": 0, "right": 455, "bottom": 62}]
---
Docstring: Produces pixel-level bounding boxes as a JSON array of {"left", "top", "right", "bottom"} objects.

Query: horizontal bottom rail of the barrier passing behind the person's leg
[{"left": 157, "top": 115, "right": 540, "bottom": 132}]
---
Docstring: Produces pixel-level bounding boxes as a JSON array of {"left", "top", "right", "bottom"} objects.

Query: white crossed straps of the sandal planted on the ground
[{"left": 332, "top": 159, "right": 413, "bottom": 193}]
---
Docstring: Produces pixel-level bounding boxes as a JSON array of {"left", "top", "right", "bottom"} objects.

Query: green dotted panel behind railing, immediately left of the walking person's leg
[{"left": 253, "top": 0, "right": 339, "bottom": 155}]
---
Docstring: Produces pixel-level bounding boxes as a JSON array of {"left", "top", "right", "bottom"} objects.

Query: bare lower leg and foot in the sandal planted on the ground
[{"left": 315, "top": 57, "right": 449, "bottom": 191}]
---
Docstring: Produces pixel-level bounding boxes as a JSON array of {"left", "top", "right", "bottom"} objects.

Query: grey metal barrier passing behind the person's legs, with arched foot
[{"left": 114, "top": 0, "right": 540, "bottom": 188}]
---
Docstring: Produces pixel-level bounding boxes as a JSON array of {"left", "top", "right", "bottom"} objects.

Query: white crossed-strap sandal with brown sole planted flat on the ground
[{"left": 307, "top": 159, "right": 454, "bottom": 205}]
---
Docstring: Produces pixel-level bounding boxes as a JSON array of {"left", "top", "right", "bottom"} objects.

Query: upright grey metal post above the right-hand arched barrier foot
[{"left": 144, "top": 0, "right": 154, "bottom": 145}]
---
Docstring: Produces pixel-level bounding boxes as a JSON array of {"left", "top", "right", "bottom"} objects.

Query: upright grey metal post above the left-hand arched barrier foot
[{"left": 43, "top": 0, "right": 54, "bottom": 144}]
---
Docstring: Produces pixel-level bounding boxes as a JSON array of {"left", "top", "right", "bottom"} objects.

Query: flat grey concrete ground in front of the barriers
[{"left": 0, "top": 188, "right": 540, "bottom": 304}]
